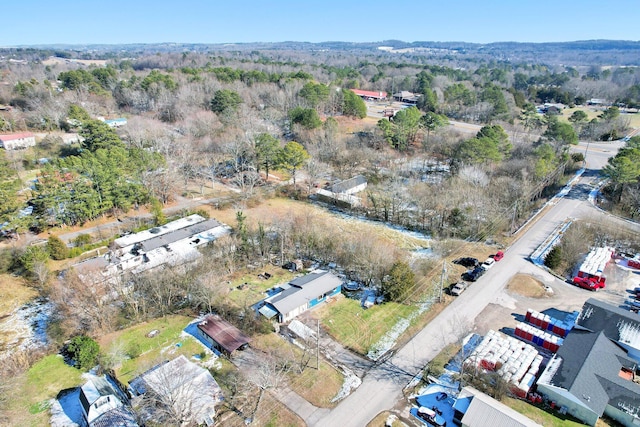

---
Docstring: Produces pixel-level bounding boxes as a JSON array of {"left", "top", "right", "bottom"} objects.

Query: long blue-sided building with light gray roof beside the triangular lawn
[{"left": 258, "top": 270, "right": 342, "bottom": 323}]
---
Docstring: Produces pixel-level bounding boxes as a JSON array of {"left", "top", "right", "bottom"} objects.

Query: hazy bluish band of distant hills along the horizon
[{"left": 0, "top": 40, "right": 640, "bottom": 66}]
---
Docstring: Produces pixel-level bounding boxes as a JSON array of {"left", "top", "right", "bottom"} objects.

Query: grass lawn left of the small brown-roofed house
[{"left": 99, "top": 315, "right": 212, "bottom": 383}]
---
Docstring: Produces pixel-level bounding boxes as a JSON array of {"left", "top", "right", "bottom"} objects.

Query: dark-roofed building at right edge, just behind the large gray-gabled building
[{"left": 576, "top": 298, "right": 640, "bottom": 362}]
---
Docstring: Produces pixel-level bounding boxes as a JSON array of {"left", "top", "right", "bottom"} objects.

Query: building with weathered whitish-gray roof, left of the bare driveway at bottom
[{"left": 129, "top": 355, "right": 223, "bottom": 426}]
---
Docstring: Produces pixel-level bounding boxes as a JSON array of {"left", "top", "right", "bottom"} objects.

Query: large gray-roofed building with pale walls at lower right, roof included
[{"left": 537, "top": 329, "right": 640, "bottom": 427}]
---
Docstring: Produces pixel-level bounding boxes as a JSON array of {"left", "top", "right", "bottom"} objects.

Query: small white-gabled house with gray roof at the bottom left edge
[{"left": 79, "top": 375, "right": 138, "bottom": 427}]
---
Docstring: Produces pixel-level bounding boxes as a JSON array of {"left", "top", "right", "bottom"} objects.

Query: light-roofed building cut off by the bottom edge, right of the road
[{"left": 453, "top": 387, "right": 542, "bottom": 427}]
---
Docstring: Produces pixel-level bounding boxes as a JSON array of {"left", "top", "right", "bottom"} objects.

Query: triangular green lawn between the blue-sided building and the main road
[{"left": 316, "top": 298, "right": 417, "bottom": 354}]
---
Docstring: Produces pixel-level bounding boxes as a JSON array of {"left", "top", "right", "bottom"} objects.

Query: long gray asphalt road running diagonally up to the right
[{"left": 316, "top": 139, "right": 622, "bottom": 427}]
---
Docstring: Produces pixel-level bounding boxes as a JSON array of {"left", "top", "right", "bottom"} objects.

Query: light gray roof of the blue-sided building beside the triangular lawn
[{"left": 270, "top": 271, "right": 342, "bottom": 314}]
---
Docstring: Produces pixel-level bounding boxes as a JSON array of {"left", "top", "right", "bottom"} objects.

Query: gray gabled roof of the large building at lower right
[{"left": 550, "top": 329, "right": 640, "bottom": 415}]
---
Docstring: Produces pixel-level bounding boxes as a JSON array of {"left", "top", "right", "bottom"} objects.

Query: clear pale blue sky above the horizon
[{"left": 5, "top": 0, "right": 640, "bottom": 46}]
